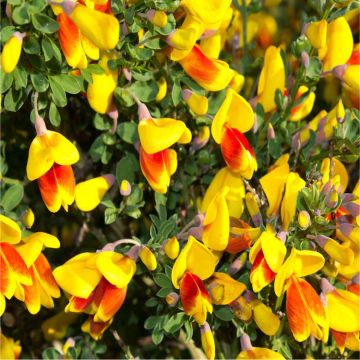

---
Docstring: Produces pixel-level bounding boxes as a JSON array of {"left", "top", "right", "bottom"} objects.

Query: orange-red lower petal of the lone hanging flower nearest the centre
[{"left": 139, "top": 146, "right": 177, "bottom": 193}]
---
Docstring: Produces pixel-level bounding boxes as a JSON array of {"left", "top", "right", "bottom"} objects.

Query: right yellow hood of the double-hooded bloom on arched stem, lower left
[{"left": 96, "top": 251, "right": 136, "bottom": 289}]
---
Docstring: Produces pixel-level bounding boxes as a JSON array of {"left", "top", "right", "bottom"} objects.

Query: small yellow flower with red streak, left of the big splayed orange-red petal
[{"left": 249, "top": 228, "right": 286, "bottom": 292}]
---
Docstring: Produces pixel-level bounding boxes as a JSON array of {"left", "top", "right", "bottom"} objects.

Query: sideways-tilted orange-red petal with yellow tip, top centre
[{"left": 179, "top": 45, "right": 234, "bottom": 91}]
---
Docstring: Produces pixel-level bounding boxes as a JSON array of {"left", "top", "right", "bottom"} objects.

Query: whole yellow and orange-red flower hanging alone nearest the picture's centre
[{"left": 138, "top": 104, "right": 191, "bottom": 193}]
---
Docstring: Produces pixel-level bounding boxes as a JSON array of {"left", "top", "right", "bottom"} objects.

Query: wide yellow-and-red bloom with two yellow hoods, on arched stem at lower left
[{"left": 53, "top": 251, "right": 136, "bottom": 339}]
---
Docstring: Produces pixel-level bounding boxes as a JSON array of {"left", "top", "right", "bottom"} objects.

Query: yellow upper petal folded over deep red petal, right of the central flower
[{"left": 211, "top": 88, "right": 254, "bottom": 144}]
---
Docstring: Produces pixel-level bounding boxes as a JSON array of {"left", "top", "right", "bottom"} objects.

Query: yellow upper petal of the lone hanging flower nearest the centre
[{"left": 138, "top": 118, "right": 191, "bottom": 154}]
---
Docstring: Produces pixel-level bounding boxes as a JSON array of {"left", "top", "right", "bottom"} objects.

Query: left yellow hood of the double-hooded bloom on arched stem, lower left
[{"left": 53, "top": 253, "right": 102, "bottom": 299}]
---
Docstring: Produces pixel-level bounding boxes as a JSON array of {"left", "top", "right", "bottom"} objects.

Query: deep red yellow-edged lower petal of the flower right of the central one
[{"left": 221, "top": 125, "right": 257, "bottom": 178}]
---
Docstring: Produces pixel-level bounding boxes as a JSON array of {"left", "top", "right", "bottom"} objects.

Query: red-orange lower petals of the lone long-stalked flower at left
[{"left": 38, "top": 164, "right": 75, "bottom": 212}]
